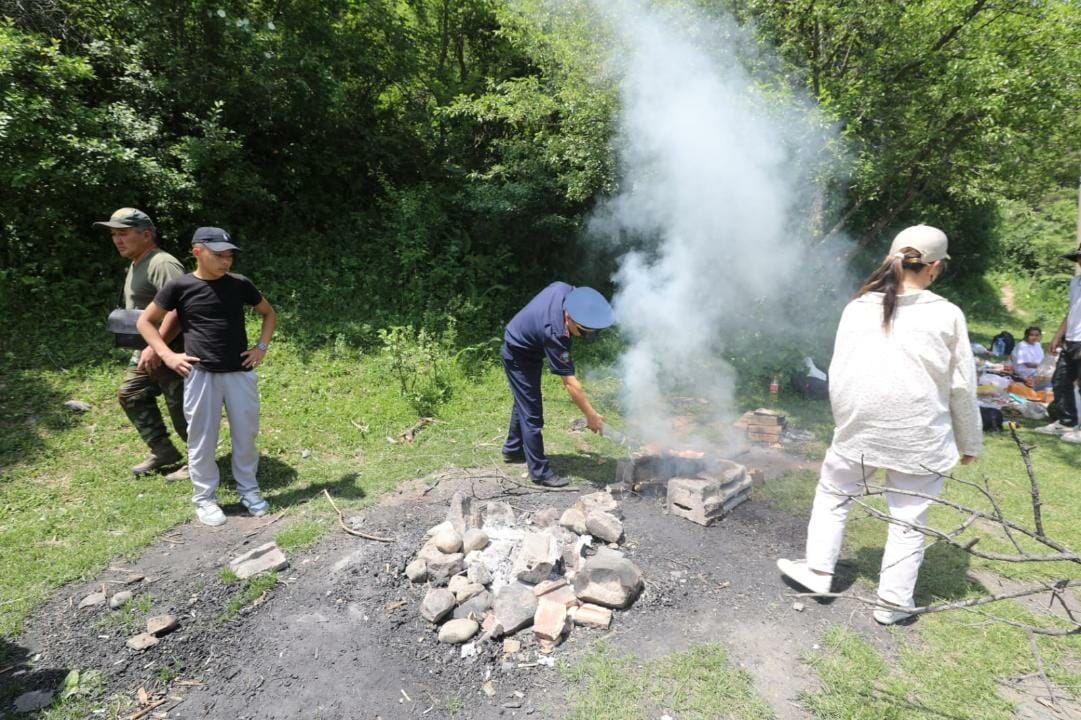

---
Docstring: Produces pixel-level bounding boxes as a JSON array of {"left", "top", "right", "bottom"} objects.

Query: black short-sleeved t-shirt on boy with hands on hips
[{"left": 154, "top": 272, "right": 263, "bottom": 373}]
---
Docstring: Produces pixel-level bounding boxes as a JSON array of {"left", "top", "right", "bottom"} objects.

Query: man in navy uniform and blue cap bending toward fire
[{"left": 502, "top": 282, "right": 614, "bottom": 488}]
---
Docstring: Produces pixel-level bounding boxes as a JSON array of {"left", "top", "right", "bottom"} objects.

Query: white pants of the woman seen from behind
[{"left": 806, "top": 448, "right": 943, "bottom": 608}]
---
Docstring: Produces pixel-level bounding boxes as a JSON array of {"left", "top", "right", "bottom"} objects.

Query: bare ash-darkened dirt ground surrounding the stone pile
[{"left": 6, "top": 453, "right": 903, "bottom": 720}]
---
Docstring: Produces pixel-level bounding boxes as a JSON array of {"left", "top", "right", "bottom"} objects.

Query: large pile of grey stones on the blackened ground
[{"left": 405, "top": 492, "right": 643, "bottom": 654}]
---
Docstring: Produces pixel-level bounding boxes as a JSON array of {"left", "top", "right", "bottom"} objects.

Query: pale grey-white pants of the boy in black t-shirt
[{"left": 184, "top": 368, "right": 259, "bottom": 505}]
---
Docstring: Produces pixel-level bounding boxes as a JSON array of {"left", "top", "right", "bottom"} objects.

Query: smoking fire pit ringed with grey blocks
[{"left": 616, "top": 451, "right": 751, "bottom": 525}]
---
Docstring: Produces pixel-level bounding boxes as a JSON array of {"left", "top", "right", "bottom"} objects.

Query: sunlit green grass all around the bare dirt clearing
[{"left": 0, "top": 265, "right": 1081, "bottom": 719}]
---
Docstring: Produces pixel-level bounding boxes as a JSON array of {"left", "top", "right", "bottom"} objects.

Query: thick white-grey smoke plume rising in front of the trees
[{"left": 589, "top": 0, "right": 851, "bottom": 445}]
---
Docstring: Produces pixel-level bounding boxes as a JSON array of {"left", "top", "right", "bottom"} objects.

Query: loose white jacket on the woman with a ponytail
[{"left": 829, "top": 290, "right": 984, "bottom": 475}]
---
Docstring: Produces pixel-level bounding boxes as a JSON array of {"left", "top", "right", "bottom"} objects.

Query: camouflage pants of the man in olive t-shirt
[{"left": 117, "top": 360, "right": 188, "bottom": 449}]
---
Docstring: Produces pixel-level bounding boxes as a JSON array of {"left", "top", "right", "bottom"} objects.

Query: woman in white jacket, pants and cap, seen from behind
[{"left": 777, "top": 225, "right": 983, "bottom": 624}]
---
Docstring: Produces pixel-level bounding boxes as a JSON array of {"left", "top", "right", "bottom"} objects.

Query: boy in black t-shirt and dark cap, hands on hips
[{"left": 138, "top": 227, "right": 277, "bottom": 525}]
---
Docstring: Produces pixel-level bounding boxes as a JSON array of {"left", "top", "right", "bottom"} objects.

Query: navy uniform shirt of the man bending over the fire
[{"left": 503, "top": 282, "right": 574, "bottom": 375}]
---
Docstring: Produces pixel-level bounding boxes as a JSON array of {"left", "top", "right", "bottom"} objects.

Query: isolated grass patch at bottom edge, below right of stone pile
[{"left": 560, "top": 641, "right": 773, "bottom": 720}]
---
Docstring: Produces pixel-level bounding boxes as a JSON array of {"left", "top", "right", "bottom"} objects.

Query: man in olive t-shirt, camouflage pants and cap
[{"left": 94, "top": 208, "right": 188, "bottom": 481}]
